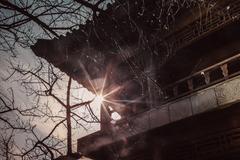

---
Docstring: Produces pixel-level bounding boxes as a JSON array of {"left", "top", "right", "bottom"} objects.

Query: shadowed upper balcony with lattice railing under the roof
[{"left": 160, "top": 0, "right": 240, "bottom": 66}]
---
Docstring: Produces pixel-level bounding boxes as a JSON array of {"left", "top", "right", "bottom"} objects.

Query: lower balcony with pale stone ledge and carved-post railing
[{"left": 78, "top": 54, "right": 240, "bottom": 154}]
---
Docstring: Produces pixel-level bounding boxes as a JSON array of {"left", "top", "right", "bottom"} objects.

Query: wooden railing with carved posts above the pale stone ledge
[{"left": 163, "top": 54, "right": 240, "bottom": 101}]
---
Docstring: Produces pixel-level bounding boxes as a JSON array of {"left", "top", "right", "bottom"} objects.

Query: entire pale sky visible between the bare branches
[{"left": 0, "top": 0, "right": 118, "bottom": 159}]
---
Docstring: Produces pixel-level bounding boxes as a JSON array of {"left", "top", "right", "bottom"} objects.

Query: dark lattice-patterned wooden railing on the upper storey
[{"left": 166, "top": 0, "right": 240, "bottom": 51}]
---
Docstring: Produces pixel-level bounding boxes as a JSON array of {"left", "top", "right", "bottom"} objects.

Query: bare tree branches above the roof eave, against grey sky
[{"left": 0, "top": 0, "right": 111, "bottom": 55}]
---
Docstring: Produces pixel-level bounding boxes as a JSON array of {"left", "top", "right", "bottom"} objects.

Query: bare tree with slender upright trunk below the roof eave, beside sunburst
[{"left": 0, "top": 57, "right": 99, "bottom": 159}]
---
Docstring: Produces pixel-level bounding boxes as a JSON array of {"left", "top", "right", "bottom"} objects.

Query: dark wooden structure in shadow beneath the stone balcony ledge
[{"left": 82, "top": 104, "right": 240, "bottom": 160}]
